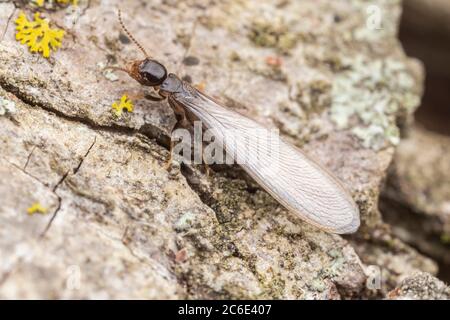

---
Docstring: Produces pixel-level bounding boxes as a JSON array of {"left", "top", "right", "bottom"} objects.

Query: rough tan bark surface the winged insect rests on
[{"left": 0, "top": 0, "right": 444, "bottom": 299}]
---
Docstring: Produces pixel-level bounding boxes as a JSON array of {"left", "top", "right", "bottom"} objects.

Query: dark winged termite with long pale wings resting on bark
[{"left": 114, "top": 11, "right": 360, "bottom": 234}]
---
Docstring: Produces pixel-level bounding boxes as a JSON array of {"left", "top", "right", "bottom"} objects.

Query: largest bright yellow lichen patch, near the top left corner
[{"left": 15, "top": 12, "right": 64, "bottom": 58}]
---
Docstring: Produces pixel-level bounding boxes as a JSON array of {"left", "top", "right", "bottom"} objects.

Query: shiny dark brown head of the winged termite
[{"left": 128, "top": 58, "right": 167, "bottom": 87}]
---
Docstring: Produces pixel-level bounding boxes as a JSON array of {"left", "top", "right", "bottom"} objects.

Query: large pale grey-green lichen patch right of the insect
[{"left": 331, "top": 56, "right": 420, "bottom": 150}]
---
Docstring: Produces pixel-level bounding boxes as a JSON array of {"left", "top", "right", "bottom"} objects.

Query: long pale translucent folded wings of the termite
[{"left": 172, "top": 84, "right": 359, "bottom": 234}]
